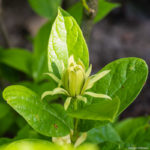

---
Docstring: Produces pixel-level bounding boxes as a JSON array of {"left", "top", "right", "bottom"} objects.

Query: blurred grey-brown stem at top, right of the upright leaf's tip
[{"left": 81, "top": 0, "right": 98, "bottom": 42}]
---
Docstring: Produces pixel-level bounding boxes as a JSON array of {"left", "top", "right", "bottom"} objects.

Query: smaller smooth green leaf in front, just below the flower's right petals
[{"left": 69, "top": 97, "right": 120, "bottom": 121}]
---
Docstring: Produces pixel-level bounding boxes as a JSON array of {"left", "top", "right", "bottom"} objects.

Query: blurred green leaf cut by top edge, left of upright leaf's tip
[{"left": 28, "top": 0, "right": 62, "bottom": 19}]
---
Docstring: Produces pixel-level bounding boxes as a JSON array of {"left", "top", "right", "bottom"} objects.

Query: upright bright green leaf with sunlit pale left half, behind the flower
[{"left": 48, "top": 9, "right": 89, "bottom": 75}]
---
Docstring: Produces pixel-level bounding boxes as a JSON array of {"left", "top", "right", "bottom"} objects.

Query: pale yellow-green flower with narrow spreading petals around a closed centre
[{"left": 41, "top": 56, "right": 111, "bottom": 110}]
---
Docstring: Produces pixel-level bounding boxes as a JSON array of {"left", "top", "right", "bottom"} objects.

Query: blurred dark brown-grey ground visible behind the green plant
[{"left": 0, "top": 0, "right": 150, "bottom": 138}]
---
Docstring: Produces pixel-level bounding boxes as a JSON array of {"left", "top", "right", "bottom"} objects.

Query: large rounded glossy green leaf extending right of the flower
[{"left": 91, "top": 57, "right": 148, "bottom": 114}]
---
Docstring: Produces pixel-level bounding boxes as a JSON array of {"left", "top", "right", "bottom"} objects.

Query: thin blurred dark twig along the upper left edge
[{"left": 0, "top": 0, "right": 11, "bottom": 48}]
